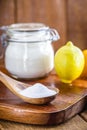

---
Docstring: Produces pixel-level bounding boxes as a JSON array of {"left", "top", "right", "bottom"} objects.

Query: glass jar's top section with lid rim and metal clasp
[{"left": 2, "top": 23, "right": 60, "bottom": 43}]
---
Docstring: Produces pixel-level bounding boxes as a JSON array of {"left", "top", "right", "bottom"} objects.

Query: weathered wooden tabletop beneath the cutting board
[{"left": 0, "top": 115, "right": 87, "bottom": 130}]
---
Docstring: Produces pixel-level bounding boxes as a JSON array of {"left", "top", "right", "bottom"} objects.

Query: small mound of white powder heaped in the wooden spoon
[{"left": 20, "top": 83, "right": 56, "bottom": 98}]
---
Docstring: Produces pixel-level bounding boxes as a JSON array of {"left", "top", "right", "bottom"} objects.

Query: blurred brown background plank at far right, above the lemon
[{"left": 67, "top": 0, "right": 87, "bottom": 49}]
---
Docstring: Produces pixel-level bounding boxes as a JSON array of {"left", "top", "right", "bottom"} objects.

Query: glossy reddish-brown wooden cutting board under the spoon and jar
[{"left": 0, "top": 69, "right": 87, "bottom": 125}]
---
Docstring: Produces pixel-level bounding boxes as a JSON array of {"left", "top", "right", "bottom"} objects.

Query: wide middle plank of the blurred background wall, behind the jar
[{"left": 16, "top": 0, "right": 66, "bottom": 49}]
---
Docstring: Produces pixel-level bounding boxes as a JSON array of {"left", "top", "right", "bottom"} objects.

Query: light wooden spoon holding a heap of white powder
[{"left": 0, "top": 71, "right": 59, "bottom": 104}]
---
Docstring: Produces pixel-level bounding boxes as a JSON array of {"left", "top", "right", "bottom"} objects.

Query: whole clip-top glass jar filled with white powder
[{"left": 1, "top": 23, "right": 59, "bottom": 79}]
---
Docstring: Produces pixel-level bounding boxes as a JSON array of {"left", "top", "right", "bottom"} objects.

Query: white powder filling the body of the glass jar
[{"left": 5, "top": 41, "right": 54, "bottom": 79}]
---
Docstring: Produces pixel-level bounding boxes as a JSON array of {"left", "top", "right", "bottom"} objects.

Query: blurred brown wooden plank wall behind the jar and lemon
[{"left": 0, "top": 0, "right": 87, "bottom": 50}]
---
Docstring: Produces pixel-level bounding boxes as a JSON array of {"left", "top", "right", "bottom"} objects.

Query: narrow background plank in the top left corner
[{"left": 0, "top": 0, "right": 15, "bottom": 26}]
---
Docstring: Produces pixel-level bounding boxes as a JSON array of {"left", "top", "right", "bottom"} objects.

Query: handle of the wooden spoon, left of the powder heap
[{"left": 0, "top": 71, "right": 31, "bottom": 102}]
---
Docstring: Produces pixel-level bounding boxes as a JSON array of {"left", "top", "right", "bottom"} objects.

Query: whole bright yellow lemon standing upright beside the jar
[{"left": 54, "top": 41, "right": 84, "bottom": 83}]
